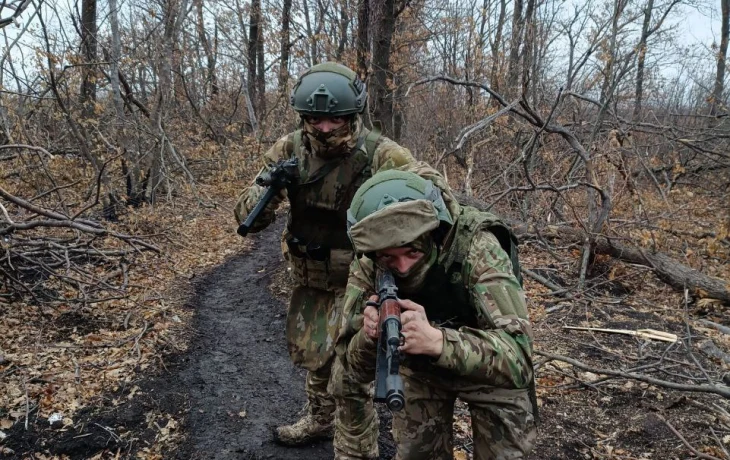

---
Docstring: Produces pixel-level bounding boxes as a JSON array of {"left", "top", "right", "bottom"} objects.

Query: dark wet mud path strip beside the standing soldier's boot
[{"left": 177, "top": 218, "right": 333, "bottom": 460}]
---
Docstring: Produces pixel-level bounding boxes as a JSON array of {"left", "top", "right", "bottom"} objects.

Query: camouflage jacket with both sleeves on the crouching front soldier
[{"left": 337, "top": 212, "right": 533, "bottom": 389}]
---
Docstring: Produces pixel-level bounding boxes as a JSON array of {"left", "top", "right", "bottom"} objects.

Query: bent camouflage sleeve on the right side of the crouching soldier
[{"left": 436, "top": 231, "right": 532, "bottom": 388}]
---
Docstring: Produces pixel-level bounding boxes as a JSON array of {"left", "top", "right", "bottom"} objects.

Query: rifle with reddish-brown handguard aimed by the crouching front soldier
[{"left": 367, "top": 270, "right": 405, "bottom": 411}]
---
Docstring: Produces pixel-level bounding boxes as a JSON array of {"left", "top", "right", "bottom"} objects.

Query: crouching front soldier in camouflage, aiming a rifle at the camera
[{"left": 337, "top": 171, "right": 536, "bottom": 460}]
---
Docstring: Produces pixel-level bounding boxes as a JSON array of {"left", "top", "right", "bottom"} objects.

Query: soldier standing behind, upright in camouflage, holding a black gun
[{"left": 235, "top": 62, "right": 450, "bottom": 458}]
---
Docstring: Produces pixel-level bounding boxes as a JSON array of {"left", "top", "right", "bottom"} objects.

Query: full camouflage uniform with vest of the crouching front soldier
[{"left": 338, "top": 207, "right": 536, "bottom": 459}]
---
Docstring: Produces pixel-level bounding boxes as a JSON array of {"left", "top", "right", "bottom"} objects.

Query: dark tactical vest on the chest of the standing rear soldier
[{"left": 286, "top": 128, "right": 380, "bottom": 289}]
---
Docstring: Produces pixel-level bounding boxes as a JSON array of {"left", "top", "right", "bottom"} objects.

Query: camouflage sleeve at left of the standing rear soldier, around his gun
[{"left": 233, "top": 134, "right": 292, "bottom": 232}]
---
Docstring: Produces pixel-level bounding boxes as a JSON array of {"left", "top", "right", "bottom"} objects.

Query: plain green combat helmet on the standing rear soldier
[{"left": 290, "top": 62, "right": 367, "bottom": 117}]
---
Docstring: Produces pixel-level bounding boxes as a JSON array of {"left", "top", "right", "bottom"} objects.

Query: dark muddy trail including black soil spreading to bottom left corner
[{"left": 0, "top": 219, "right": 333, "bottom": 460}]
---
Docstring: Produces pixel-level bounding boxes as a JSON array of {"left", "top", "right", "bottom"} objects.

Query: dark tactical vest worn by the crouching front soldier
[{"left": 396, "top": 206, "right": 522, "bottom": 329}]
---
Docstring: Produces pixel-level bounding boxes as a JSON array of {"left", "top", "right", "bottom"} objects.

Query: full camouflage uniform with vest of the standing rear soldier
[{"left": 235, "top": 123, "right": 450, "bottom": 458}]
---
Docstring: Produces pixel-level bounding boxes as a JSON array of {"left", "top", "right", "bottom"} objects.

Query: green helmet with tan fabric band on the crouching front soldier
[{"left": 347, "top": 169, "right": 454, "bottom": 254}]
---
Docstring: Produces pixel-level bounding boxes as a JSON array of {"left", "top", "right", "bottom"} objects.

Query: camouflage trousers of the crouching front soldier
[{"left": 393, "top": 368, "right": 537, "bottom": 460}]
